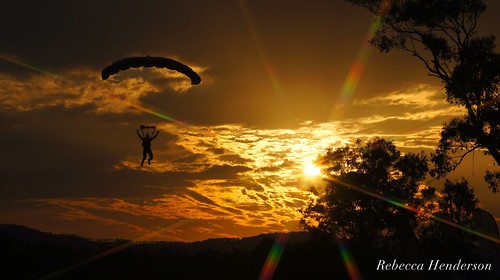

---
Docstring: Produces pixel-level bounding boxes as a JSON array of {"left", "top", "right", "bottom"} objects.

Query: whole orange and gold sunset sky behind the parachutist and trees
[{"left": 0, "top": 0, "right": 500, "bottom": 241}]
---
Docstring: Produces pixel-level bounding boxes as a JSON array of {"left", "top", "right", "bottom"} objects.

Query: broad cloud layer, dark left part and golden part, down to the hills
[{"left": 1, "top": 72, "right": 476, "bottom": 240}]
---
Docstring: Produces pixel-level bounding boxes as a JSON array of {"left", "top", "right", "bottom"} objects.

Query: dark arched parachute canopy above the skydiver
[{"left": 101, "top": 56, "right": 201, "bottom": 85}]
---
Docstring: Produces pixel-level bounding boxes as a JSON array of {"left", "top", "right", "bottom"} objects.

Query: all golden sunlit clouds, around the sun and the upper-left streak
[{"left": 0, "top": 65, "right": 480, "bottom": 241}]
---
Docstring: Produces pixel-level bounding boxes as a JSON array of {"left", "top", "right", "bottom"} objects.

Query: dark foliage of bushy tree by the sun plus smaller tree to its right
[{"left": 300, "top": 138, "right": 478, "bottom": 262}]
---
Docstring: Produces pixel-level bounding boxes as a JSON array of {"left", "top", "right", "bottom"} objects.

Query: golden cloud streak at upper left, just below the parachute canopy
[{"left": 0, "top": 63, "right": 210, "bottom": 113}]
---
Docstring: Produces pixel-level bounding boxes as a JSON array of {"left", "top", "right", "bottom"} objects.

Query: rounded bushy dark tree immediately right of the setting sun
[{"left": 301, "top": 138, "right": 428, "bottom": 246}]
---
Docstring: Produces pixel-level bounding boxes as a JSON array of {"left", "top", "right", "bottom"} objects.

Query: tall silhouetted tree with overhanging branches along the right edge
[{"left": 346, "top": 0, "right": 500, "bottom": 192}]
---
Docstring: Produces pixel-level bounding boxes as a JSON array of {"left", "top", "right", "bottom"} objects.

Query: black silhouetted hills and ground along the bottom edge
[{"left": 0, "top": 225, "right": 500, "bottom": 280}]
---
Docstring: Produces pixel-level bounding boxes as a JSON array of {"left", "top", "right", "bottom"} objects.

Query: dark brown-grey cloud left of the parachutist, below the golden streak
[{"left": 0, "top": 106, "right": 183, "bottom": 198}]
